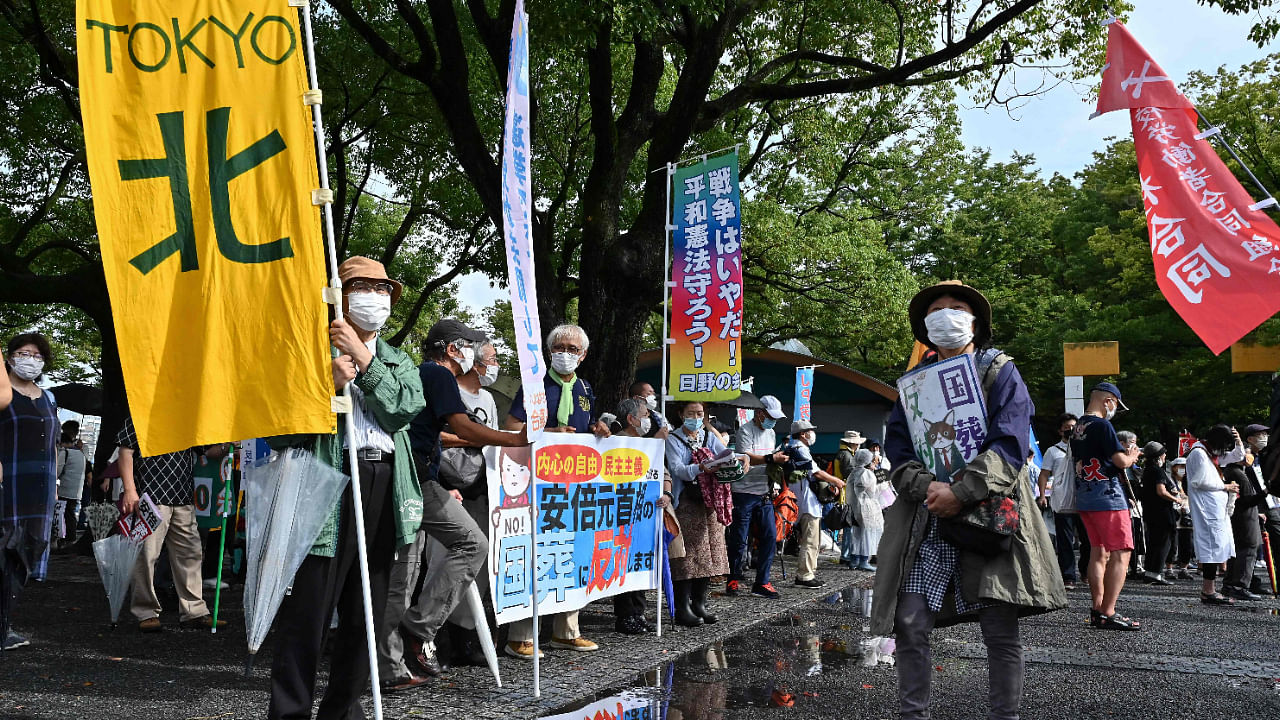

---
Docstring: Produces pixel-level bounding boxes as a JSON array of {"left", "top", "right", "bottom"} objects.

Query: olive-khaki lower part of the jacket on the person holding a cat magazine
[{"left": 870, "top": 450, "right": 1066, "bottom": 635}]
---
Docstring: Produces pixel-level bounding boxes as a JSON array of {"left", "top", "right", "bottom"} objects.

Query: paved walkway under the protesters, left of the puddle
[{"left": 0, "top": 540, "right": 870, "bottom": 720}]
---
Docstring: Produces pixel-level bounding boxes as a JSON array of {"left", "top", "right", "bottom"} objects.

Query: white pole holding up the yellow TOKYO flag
[{"left": 289, "top": 0, "right": 383, "bottom": 720}]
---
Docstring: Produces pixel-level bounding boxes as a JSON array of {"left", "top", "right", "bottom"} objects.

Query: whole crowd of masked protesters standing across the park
[{"left": 0, "top": 267, "right": 1280, "bottom": 719}]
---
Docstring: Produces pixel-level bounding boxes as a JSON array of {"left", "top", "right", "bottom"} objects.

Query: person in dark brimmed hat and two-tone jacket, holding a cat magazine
[{"left": 870, "top": 281, "right": 1066, "bottom": 719}]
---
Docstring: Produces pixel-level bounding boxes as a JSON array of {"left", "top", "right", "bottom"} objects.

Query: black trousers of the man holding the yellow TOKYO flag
[{"left": 268, "top": 460, "right": 396, "bottom": 720}]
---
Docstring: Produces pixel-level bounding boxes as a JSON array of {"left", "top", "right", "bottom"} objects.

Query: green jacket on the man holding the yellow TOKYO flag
[{"left": 268, "top": 338, "right": 426, "bottom": 557}]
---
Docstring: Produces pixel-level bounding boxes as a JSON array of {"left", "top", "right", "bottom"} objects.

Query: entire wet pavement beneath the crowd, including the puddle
[{"left": 0, "top": 545, "right": 1280, "bottom": 720}]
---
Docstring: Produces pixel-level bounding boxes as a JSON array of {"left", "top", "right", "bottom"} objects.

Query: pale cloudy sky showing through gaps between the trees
[{"left": 458, "top": 0, "right": 1280, "bottom": 319}]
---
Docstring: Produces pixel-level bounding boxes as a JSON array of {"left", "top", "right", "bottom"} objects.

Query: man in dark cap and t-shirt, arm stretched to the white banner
[{"left": 378, "top": 319, "right": 527, "bottom": 678}]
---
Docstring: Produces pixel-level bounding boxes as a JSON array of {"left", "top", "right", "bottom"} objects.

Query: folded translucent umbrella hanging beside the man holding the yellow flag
[{"left": 243, "top": 448, "right": 349, "bottom": 675}]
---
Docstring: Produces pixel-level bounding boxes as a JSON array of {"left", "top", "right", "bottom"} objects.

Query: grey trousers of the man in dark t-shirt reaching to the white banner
[{"left": 378, "top": 482, "right": 489, "bottom": 682}]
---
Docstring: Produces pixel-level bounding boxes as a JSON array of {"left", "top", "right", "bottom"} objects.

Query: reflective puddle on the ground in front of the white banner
[{"left": 544, "top": 588, "right": 893, "bottom": 720}]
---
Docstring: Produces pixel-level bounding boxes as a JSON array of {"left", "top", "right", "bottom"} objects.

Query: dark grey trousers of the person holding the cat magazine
[{"left": 893, "top": 593, "right": 1024, "bottom": 720}]
